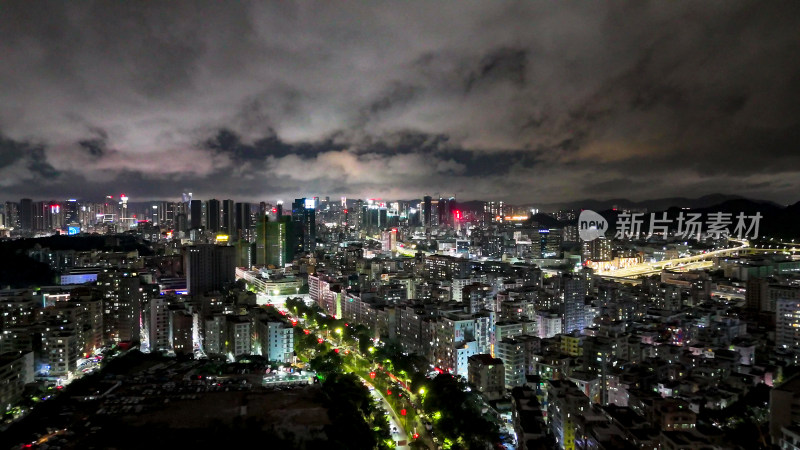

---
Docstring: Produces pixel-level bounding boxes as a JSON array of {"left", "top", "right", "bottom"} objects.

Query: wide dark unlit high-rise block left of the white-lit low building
[{"left": 183, "top": 244, "right": 236, "bottom": 295}]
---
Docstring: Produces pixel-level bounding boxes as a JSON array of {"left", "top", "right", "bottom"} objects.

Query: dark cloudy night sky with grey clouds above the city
[{"left": 0, "top": 0, "right": 800, "bottom": 203}]
